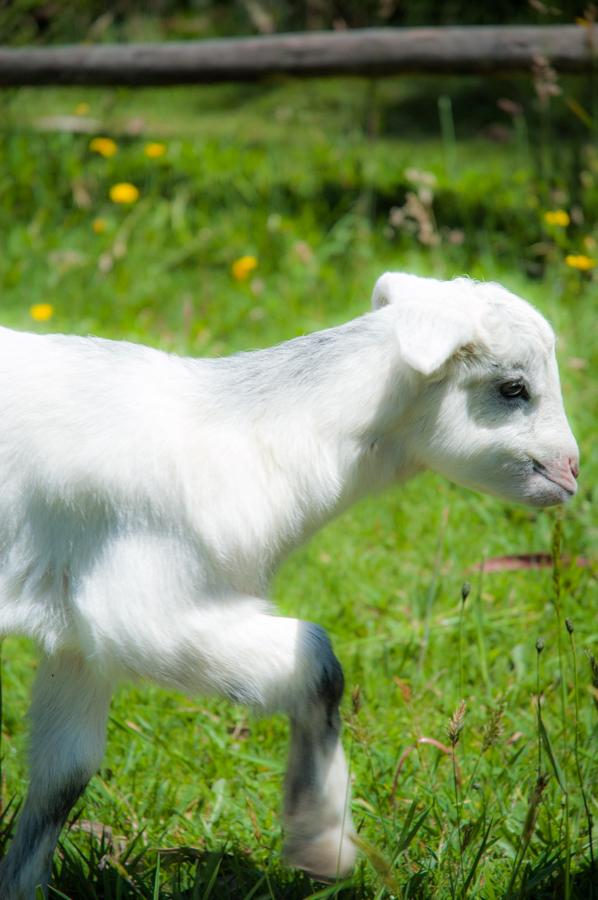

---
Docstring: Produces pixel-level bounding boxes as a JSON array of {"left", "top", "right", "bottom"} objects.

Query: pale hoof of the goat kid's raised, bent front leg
[{"left": 283, "top": 826, "right": 357, "bottom": 881}]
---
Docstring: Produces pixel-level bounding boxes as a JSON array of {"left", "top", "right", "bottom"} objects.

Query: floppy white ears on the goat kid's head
[{"left": 372, "top": 272, "right": 475, "bottom": 376}]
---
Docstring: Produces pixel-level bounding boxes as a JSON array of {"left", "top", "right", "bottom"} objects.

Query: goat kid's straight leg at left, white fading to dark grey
[{"left": 0, "top": 652, "right": 112, "bottom": 900}]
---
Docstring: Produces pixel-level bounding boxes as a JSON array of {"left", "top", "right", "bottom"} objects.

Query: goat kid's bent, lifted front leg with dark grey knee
[{"left": 148, "top": 598, "right": 356, "bottom": 879}]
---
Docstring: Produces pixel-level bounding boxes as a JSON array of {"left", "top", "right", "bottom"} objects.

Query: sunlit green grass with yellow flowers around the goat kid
[{"left": 0, "top": 79, "right": 598, "bottom": 900}]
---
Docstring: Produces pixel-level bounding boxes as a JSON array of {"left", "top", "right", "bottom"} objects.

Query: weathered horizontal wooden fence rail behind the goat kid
[{"left": 0, "top": 25, "right": 598, "bottom": 86}]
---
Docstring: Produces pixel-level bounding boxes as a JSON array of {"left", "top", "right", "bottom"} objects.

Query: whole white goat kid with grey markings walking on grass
[{"left": 0, "top": 274, "right": 577, "bottom": 900}]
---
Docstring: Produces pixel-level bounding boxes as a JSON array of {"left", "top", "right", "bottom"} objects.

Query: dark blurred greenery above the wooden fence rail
[{"left": 0, "top": 0, "right": 593, "bottom": 45}]
